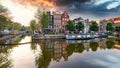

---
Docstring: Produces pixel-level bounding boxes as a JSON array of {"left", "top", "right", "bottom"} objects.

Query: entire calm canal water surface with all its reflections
[{"left": 0, "top": 36, "right": 120, "bottom": 68}]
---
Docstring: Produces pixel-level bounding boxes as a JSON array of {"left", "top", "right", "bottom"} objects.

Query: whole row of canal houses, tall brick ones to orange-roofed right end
[{"left": 45, "top": 11, "right": 120, "bottom": 33}]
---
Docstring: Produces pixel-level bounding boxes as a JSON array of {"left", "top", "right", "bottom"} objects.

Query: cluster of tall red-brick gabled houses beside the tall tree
[{"left": 46, "top": 11, "right": 70, "bottom": 33}]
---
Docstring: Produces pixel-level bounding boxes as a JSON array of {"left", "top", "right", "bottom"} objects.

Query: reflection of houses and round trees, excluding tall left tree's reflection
[{"left": 36, "top": 38, "right": 117, "bottom": 62}]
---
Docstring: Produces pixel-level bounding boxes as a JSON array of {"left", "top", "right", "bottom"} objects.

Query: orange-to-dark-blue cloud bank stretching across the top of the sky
[{"left": 3, "top": 0, "right": 120, "bottom": 19}]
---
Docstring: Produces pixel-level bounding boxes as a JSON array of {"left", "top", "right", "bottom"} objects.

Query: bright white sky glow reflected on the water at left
[{"left": 11, "top": 37, "right": 40, "bottom": 68}]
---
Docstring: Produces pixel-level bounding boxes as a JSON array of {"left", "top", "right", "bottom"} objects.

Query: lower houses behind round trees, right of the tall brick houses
[{"left": 73, "top": 17, "right": 120, "bottom": 33}]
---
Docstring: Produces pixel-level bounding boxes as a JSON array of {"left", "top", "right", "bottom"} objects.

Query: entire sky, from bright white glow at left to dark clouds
[{"left": 0, "top": 0, "right": 120, "bottom": 26}]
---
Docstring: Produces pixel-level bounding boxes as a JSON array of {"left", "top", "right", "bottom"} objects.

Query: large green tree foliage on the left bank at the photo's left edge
[{"left": 0, "top": 5, "right": 25, "bottom": 30}]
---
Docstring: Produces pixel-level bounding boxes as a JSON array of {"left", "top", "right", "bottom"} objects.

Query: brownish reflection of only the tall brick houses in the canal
[{"left": 41, "top": 40, "right": 68, "bottom": 62}]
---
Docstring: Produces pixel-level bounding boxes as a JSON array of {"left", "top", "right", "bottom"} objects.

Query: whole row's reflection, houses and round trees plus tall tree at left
[{"left": 32, "top": 38, "right": 118, "bottom": 68}]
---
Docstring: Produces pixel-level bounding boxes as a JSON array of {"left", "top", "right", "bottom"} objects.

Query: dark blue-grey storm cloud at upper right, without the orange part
[{"left": 53, "top": 0, "right": 120, "bottom": 19}]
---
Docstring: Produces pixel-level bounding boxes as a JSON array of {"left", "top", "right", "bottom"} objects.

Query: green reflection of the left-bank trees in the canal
[{"left": 0, "top": 36, "right": 25, "bottom": 68}]
